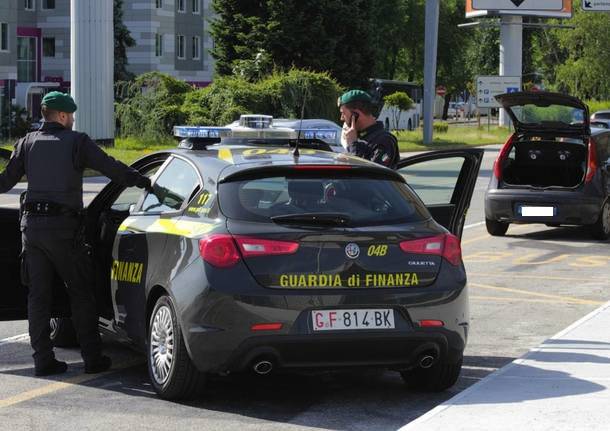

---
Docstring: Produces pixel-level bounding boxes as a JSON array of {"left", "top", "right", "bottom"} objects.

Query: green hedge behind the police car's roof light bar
[{"left": 116, "top": 69, "right": 342, "bottom": 138}]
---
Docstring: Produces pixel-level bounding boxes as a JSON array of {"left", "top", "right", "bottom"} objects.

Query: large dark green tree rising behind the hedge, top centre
[{"left": 211, "top": 0, "right": 382, "bottom": 86}]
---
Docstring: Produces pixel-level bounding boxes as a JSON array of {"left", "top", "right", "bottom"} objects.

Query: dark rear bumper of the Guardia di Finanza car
[{"left": 179, "top": 286, "right": 469, "bottom": 373}]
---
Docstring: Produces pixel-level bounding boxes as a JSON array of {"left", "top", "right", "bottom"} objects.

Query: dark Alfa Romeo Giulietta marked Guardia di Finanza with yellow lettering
[{"left": 0, "top": 128, "right": 482, "bottom": 399}]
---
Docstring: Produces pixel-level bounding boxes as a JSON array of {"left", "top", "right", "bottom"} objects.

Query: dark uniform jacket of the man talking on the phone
[{"left": 349, "top": 121, "right": 400, "bottom": 168}]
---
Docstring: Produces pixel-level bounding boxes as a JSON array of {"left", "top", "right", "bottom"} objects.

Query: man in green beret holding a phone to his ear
[{"left": 337, "top": 90, "right": 400, "bottom": 168}]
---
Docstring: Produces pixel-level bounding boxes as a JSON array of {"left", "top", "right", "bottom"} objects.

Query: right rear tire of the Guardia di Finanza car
[{"left": 400, "top": 357, "right": 462, "bottom": 392}]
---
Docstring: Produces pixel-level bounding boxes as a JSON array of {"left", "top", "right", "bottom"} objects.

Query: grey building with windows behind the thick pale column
[{"left": 0, "top": 0, "right": 214, "bottom": 134}]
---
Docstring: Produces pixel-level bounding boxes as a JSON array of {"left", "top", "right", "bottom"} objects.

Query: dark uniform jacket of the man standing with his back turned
[{"left": 0, "top": 122, "right": 141, "bottom": 227}]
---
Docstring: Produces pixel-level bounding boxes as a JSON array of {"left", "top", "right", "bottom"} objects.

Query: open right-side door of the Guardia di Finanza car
[{"left": 396, "top": 149, "right": 483, "bottom": 238}]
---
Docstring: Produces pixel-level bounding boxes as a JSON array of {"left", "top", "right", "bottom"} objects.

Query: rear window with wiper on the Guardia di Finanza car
[{"left": 219, "top": 176, "right": 430, "bottom": 226}]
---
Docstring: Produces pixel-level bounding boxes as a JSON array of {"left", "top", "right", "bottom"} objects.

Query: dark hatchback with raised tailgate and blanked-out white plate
[{"left": 485, "top": 92, "right": 610, "bottom": 240}]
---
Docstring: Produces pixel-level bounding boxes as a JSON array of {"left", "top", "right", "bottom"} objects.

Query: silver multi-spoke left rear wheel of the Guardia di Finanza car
[{"left": 146, "top": 295, "right": 205, "bottom": 400}]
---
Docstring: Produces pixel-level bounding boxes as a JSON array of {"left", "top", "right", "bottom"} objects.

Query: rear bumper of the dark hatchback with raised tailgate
[{"left": 485, "top": 189, "right": 603, "bottom": 225}]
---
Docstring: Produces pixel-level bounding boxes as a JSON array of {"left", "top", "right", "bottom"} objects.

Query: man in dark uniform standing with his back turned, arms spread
[{"left": 0, "top": 91, "right": 150, "bottom": 376}]
